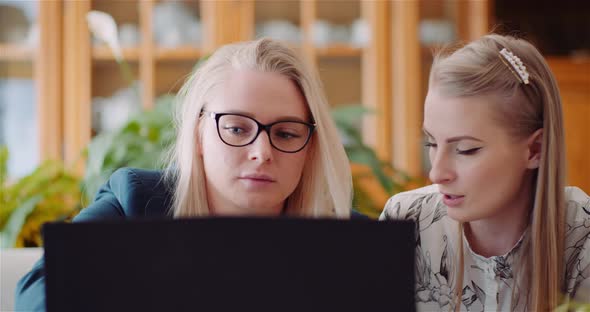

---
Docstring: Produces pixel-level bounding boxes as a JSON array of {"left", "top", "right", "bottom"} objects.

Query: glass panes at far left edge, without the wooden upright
[{"left": 0, "top": 1, "right": 40, "bottom": 178}]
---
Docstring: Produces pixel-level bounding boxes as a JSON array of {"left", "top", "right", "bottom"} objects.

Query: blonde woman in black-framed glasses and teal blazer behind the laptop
[{"left": 16, "top": 39, "right": 362, "bottom": 311}]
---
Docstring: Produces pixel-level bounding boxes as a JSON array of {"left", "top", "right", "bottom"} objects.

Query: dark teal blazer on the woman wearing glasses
[{"left": 15, "top": 168, "right": 367, "bottom": 311}]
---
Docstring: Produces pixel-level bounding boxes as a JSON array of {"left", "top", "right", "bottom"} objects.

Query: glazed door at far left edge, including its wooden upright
[{"left": 0, "top": 0, "right": 63, "bottom": 179}]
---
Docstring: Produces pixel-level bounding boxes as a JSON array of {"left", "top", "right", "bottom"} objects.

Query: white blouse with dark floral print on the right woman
[{"left": 380, "top": 185, "right": 590, "bottom": 311}]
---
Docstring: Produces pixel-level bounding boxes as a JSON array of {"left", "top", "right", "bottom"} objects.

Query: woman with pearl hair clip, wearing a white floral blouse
[{"left": 381, "top": 34, "right": 590, "bottom": 311}]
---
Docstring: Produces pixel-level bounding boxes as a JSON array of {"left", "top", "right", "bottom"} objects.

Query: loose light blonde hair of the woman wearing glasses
[{"left": 165, "top": 39, "right": 352, "bottom": 218}]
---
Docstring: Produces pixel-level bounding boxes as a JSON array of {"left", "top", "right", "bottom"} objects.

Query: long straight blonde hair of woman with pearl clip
[{"left": 430, "top": 34, "right": 566, "bottom": 311}]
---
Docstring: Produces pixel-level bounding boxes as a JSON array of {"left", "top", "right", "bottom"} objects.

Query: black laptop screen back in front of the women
[{"left": 43, "top": 218, "right": 415, "bottom": 312}]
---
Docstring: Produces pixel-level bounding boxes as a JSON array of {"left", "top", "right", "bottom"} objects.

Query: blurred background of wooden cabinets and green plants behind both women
[{"left": 0, "top": 0, "right": 590, "bottom": 247}]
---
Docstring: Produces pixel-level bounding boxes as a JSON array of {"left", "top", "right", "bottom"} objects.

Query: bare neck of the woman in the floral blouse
[{"left": 464, "top": 179, "right": 534, "bottom": 257}]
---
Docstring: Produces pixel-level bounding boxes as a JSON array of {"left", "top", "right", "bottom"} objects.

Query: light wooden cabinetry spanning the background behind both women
[{"left": 0, "top": 0, "right": 590, "bottom": 190}]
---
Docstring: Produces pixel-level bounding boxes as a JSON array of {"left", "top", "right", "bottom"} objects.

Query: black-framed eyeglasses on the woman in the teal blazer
[{"left": 201, "top": 111, "right": 316, "bottom": 153}]
